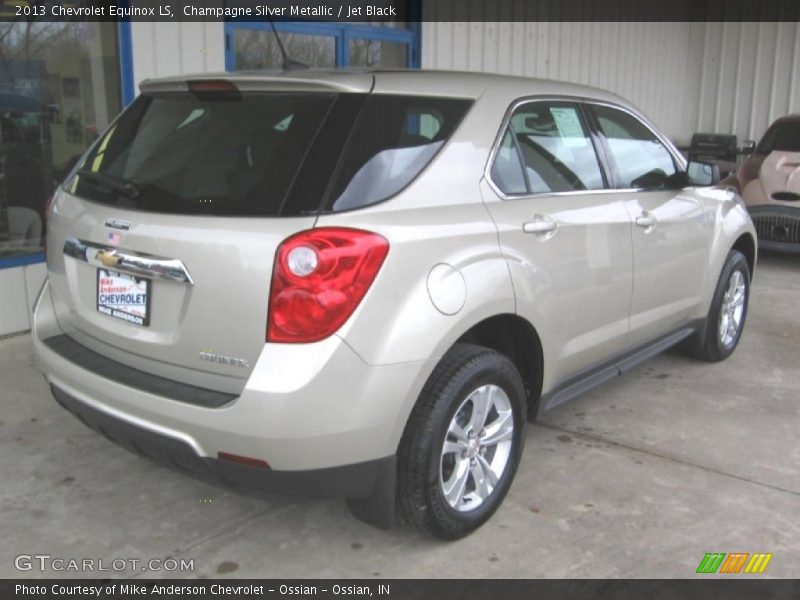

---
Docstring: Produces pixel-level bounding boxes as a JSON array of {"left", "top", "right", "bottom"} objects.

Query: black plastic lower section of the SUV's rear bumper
[{"left": 51, "top": 386, "right": 395, "bottom": 498}]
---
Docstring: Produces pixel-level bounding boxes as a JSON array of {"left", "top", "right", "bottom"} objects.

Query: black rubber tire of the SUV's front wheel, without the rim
[{"left": 683, "top": 250, "right": 750, "bottom": 362}]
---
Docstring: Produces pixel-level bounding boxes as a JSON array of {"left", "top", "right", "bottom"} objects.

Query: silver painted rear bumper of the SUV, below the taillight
[{"left": 33, "top": 285, "right": 435, "bottom": 474}]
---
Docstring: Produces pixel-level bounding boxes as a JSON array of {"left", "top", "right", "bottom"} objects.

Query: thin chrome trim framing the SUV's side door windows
[{"left": 483, "top": 95, "right": 686, "bottom": 200}]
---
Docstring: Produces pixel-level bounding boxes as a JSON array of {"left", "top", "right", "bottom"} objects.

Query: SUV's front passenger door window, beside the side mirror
[{"left": 592, "top": 106, "right": 677, "bottom": 188}]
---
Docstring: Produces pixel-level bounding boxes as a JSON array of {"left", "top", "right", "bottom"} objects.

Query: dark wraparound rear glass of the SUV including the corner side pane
[{"left": 67, "top": 93, "right": 470, "bottom": 216}]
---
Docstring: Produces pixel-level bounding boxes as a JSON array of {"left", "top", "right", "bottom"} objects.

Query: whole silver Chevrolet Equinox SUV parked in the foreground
[{"left": 34, "top": 71, "right": 756, "bottom": 539}]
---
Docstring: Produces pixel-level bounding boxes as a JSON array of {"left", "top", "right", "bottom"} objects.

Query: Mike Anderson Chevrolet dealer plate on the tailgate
[{"left": 97, "top": 269, "right": 152, "bottom": 327}]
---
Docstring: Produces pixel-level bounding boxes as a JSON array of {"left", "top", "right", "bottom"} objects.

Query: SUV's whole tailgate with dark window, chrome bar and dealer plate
[{"left": 48, "top": 82, "right": 366, "bottom": 391}]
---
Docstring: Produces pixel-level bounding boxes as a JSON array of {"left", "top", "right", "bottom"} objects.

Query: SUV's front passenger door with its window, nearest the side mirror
[{"left": 590, "top": 104, "right": 710, "bottom": 346}]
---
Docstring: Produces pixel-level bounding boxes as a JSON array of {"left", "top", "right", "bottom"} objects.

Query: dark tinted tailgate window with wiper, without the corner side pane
[{"left": 73, "top": 93, "right": 336, "bottom": 215}]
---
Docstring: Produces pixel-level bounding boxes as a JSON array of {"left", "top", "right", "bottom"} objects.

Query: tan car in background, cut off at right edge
[{"left": 722, "top": 114, "right": 800, "bottom": 252}]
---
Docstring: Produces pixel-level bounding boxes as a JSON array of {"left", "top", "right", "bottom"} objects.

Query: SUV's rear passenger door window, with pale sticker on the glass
[{"left": 496, "top": 102, "right": 605, "bottom": 194}]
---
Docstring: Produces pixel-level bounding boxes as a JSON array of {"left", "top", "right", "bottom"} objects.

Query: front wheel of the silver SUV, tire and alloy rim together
[{"left": 685, "top": 250, "right": 750, "bottom": 362}]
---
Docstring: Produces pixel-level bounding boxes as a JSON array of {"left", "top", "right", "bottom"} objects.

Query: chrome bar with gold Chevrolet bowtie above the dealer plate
[{"left": 64, "top": 238, "right": 194, "bottom": 285}]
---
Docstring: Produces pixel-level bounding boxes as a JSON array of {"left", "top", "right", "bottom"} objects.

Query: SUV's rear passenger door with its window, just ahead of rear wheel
[{"left": 484, "top": 100, "right": 633, "bottom": 387}]
